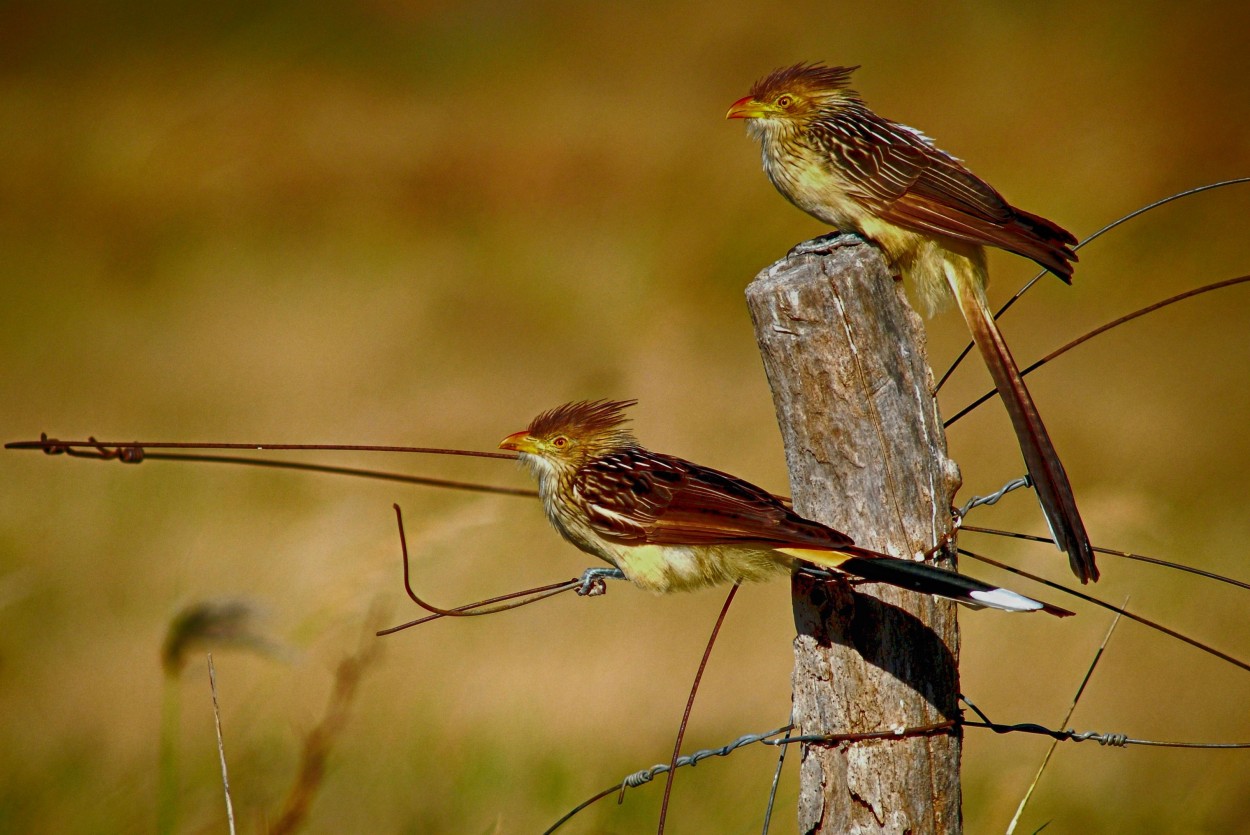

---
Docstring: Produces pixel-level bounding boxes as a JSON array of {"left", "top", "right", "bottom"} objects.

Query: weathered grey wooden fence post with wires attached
[{"left": 746, "top": 237, "right": 963, "bottom": 835}]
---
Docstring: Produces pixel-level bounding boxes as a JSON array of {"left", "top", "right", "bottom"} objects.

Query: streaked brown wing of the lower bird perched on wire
[{"left": 573, "top": 448, "right": 851, "bottom": 548}]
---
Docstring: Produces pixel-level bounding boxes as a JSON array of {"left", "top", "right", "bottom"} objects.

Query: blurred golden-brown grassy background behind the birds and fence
[{"left": 0, "top": 0, "right": 1250, "bottom": 833}]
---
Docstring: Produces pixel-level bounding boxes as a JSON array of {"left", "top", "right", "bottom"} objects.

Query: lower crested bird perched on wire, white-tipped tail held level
[{"left": 499, "top": 400, "right": 1073, "bottom": 616}]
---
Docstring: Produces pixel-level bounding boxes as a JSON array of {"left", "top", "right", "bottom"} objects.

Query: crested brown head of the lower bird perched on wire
[{"left": 499, "top": 400, "right": 638, "bottom": 470}]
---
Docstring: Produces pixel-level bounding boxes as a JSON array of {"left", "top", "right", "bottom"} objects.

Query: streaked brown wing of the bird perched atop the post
[{"left": 816, "top": 109, "right": 1076, "bottom": 280}]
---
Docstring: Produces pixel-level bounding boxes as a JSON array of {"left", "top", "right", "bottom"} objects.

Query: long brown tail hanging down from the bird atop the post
[{"left": 946, "top": 263, "right": 1099, "bottom": 583}]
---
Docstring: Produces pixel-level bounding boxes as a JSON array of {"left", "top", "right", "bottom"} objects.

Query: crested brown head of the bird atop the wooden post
[{"left": 725, "top": 64, "right": 860, "bottom": 129}]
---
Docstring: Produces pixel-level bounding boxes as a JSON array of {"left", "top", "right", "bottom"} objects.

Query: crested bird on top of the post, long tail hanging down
[{"left": 726, "top": 64, "right": 1099, "bottom": 583}]
